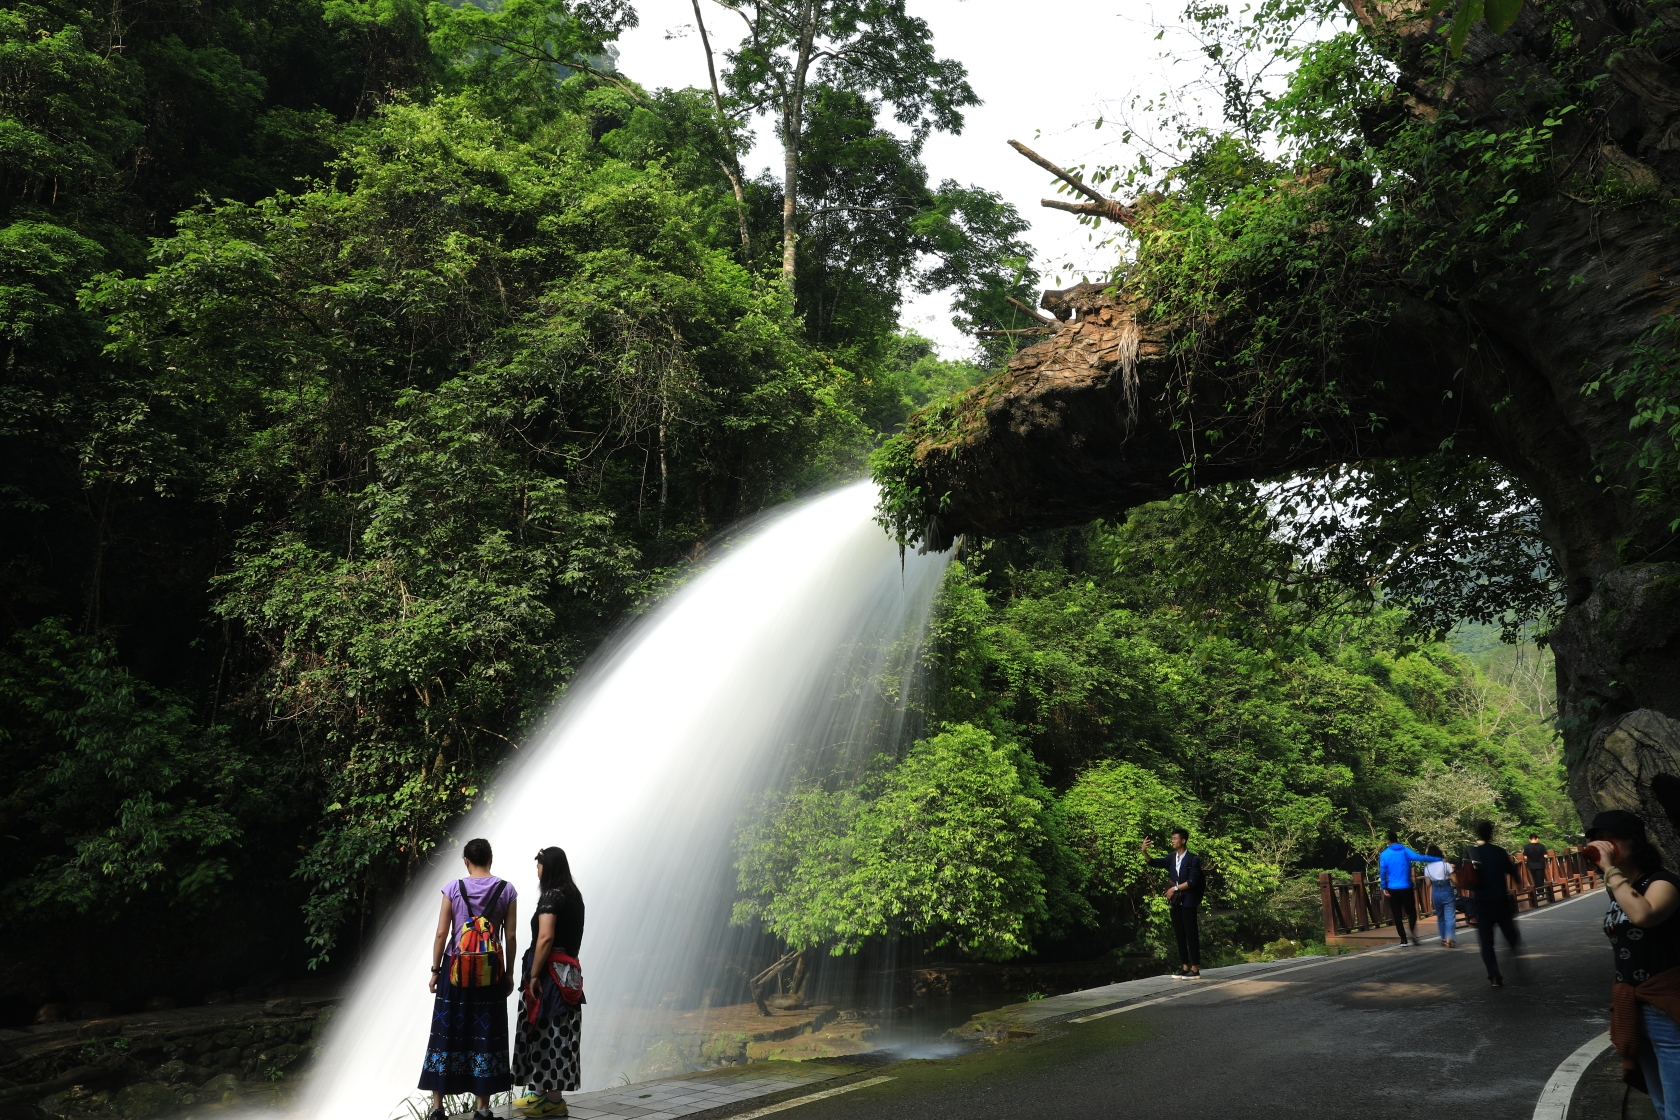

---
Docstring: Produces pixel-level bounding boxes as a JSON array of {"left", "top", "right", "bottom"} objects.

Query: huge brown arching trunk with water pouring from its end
[{"left": 909, "top": 0, "right": 1680, "bottom": 860}]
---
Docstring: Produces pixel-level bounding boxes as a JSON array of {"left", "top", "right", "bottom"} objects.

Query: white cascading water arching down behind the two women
[{"left": 307, "top": 484, "right": 944, "bottom": 1120}]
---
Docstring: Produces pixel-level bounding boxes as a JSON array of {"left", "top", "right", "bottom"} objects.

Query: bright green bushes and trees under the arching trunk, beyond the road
[{"left": 739, "top": 489, "right": 1576, "bottom": 959}]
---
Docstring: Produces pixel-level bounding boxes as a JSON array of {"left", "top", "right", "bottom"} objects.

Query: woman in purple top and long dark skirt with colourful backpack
[{"left": 420, "top": 840, "right": 517, "bottom": 1120}]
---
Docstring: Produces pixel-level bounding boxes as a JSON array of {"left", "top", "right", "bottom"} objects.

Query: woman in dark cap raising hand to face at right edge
[{"left": 1584, "top": 809, "right": 1680, "bottom": 1120}]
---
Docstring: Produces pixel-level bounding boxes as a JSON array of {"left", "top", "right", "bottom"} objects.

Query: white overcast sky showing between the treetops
[{"left": 618, "top": 0, "right": 1193, "bottom": 358}]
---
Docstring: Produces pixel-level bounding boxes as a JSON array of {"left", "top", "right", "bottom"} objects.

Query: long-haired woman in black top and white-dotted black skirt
[{"left": 512, "top": 848, "right": 586, "bottom": 1117}]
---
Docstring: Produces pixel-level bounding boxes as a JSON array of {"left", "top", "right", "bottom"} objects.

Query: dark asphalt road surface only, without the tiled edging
[{"left": 790, "top": 893, "right": 1620, "bottom": 1120}]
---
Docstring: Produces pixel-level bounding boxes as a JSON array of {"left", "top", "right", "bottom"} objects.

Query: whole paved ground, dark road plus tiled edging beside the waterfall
[{"left": 477, "top": 897, "right": 1612, "bottom": 1120}]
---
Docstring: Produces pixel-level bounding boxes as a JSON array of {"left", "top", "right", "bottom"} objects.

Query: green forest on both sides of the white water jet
[{"left": 0, "top": 0, "right": 1571, "bottom": 1018}]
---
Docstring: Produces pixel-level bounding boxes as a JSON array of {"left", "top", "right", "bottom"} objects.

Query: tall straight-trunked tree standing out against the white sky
[{"left": 717, "top": 0, "right": 979, "bottom": 285}]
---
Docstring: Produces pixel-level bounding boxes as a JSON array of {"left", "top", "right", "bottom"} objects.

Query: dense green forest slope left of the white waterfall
[{"left": 0, "top": 0, "right": 1033, "bottom": 1016}]
